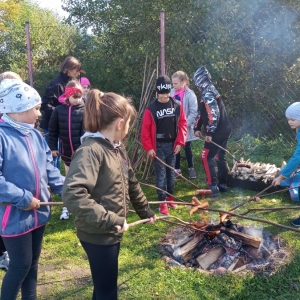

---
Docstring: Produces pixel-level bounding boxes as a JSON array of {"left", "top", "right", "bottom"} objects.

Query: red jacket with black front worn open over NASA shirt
[{"left": 141, "top": 97, "right": 187, "bottom": 152}]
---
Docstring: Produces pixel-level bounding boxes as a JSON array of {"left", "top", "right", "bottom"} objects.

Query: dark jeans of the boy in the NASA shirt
[{"left": 154, "top": 142, "right": 176, "bottom": 201}]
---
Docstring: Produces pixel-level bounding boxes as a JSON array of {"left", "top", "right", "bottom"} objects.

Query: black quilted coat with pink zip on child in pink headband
[{"left": 48, "top": 104, "right": 84, "bottom": 165}]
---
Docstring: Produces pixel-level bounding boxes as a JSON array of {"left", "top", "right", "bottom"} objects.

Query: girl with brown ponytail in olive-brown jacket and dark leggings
[{"left": 62, "top": 89, "right": 155, "bottom": 300}]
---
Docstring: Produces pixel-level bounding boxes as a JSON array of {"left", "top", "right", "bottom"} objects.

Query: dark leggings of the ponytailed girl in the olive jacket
[{"left": 80, "top": 241, "right": 120, "bottom": 300}]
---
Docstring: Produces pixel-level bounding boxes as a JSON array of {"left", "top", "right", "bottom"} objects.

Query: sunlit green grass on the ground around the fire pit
[{"left": 0, "top": 142, "right": 300, "bottom": 300}]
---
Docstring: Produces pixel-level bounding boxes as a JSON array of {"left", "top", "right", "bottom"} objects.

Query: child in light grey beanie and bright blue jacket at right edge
[{"left": 272, "top": 102, "right": 300, "bottom": 227}]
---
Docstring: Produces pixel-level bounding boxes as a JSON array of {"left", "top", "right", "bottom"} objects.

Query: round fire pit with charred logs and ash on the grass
[{"left": 161, "top": 220, "right": 290, "bottom": 276}]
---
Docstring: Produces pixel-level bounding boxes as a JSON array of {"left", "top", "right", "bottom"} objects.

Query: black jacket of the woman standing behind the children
[{"left": 40, "top": 72, "right": 72, "bottom": 130}]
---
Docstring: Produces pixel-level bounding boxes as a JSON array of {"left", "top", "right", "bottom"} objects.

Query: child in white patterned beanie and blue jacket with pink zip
[{"left": 0, "top": 79, "right": 64, "bottom": 300}]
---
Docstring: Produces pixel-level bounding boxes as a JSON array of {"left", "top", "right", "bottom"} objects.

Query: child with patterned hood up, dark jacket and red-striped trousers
[{"left": 193, "top": 66, "right": 231, "bottom": 195}]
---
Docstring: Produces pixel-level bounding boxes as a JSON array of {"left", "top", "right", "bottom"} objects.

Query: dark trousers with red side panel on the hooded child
[{"left": 201, "top": 136, "right": 229, "bottom": 185}]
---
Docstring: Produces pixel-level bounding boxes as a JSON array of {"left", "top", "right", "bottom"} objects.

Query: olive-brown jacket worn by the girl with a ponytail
[{"left": 62, "top": 132, "right": 155, "bottom": 245}]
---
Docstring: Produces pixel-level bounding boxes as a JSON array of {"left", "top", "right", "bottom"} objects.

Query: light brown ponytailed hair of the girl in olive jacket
[{"left": 84, "top": 89, "right": 136, "bottom": 132}]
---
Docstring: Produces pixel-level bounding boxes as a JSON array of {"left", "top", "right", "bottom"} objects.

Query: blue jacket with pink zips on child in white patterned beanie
[{"left": 0, "top": 120, "right": 64, "bottom": 237}]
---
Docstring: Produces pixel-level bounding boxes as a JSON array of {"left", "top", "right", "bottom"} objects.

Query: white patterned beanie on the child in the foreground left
[{"left": 0, "top": 79, "right": 41, "bottom": 114}]
